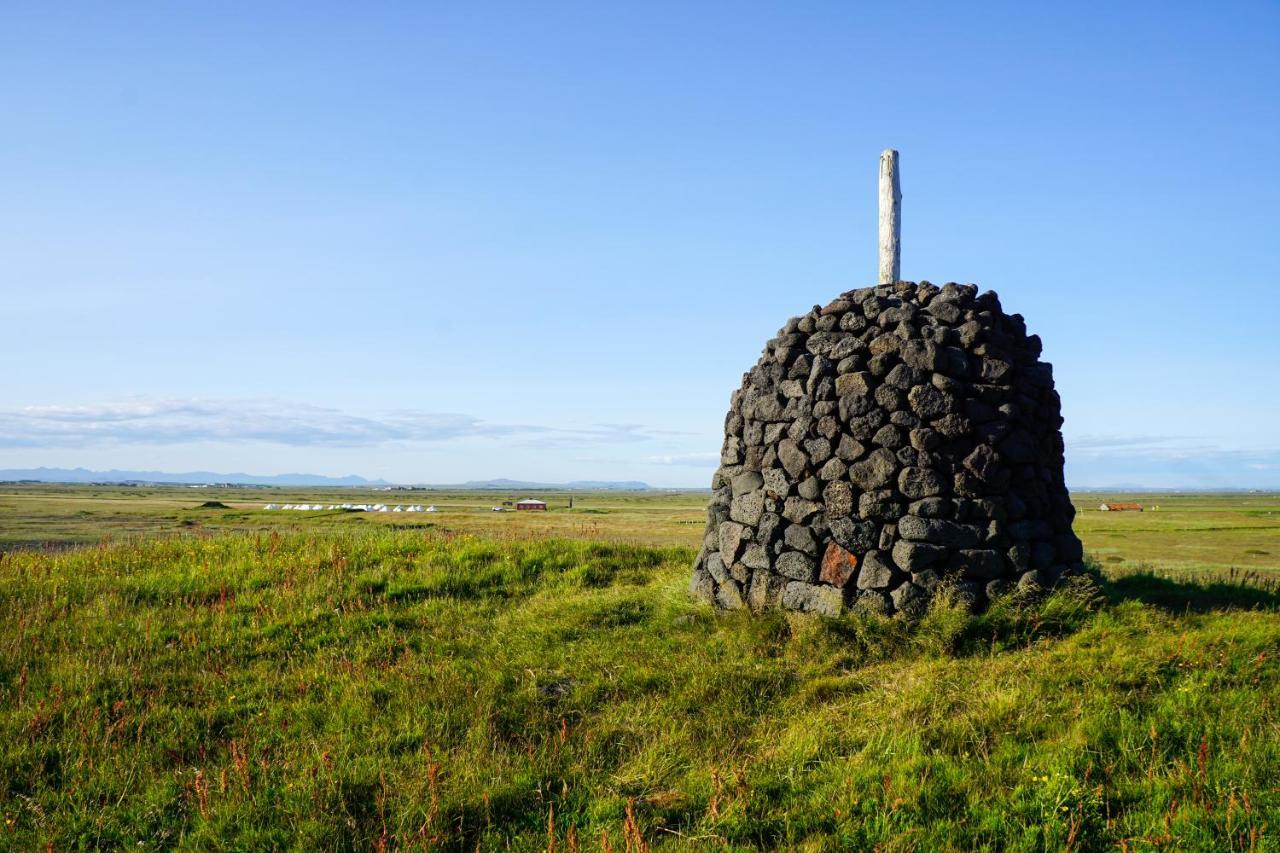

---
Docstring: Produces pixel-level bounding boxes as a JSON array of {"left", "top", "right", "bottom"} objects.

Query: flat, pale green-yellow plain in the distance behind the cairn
[{"left": 0, "top": 484, "right": 1280, "bottom": 576}]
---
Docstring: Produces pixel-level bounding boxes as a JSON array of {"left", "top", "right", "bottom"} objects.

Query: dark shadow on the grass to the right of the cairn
[{"left": 1103, "top": 571, "right": 1280, "bottom": 613}]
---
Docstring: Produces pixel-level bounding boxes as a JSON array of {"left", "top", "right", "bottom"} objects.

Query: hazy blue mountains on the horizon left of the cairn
[{"left": 0, "top": 467, "right": 652, "bottom": 492}]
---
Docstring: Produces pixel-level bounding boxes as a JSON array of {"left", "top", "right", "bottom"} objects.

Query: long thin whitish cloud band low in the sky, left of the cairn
[{"left": 0, "top": 398, "right": 675, "bottom": 448}]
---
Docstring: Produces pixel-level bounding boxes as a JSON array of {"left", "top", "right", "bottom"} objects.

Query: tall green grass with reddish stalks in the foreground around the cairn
[{"left": 0, "top": 528, "right": 1280, "bottom": 852}]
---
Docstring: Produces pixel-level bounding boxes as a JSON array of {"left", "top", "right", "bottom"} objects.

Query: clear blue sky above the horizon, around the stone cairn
[{"left": 0, "top": 3, "right": 1280, "bottom": 488}]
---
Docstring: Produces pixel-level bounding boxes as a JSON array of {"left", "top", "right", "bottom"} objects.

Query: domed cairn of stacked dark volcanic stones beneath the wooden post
[{"left": 690, "top": 280, "right": 1083, "bottom": 616}]
